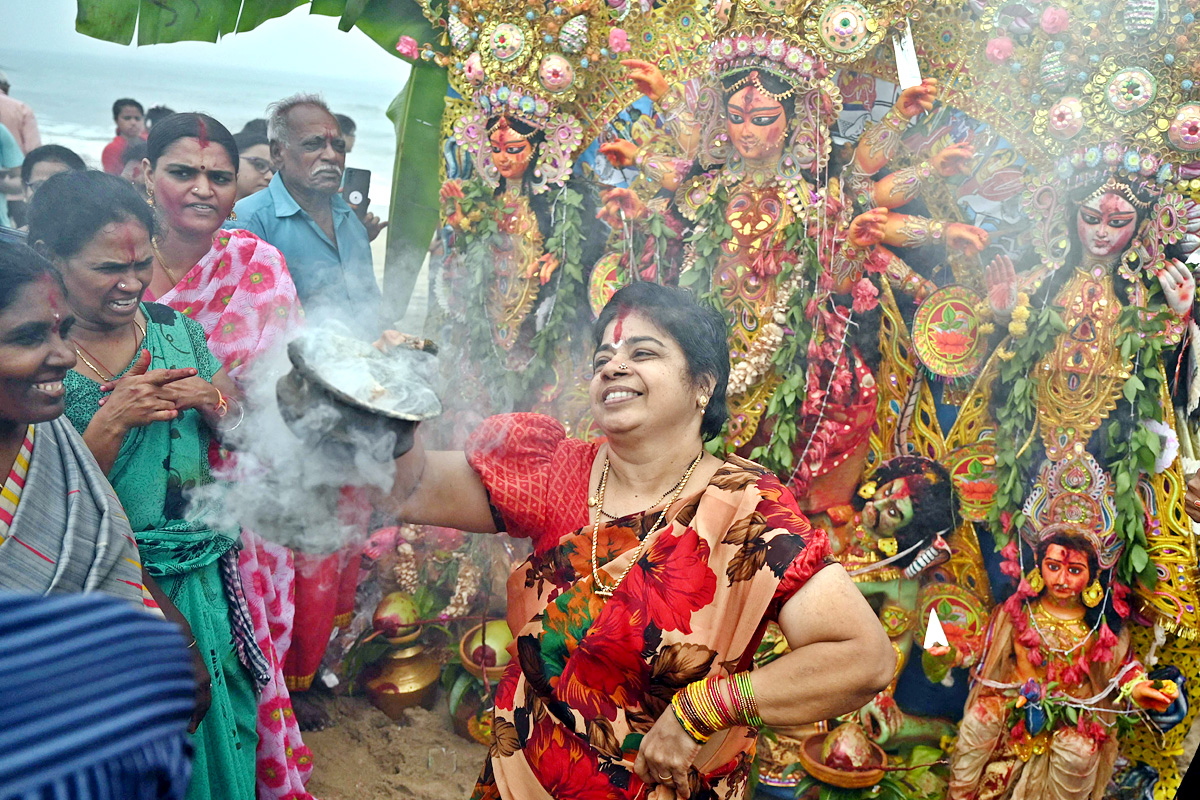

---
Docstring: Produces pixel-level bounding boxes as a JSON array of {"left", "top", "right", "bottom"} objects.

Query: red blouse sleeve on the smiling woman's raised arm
[{"left": 466, "top": 413, "right": 595, "bottom": 552}]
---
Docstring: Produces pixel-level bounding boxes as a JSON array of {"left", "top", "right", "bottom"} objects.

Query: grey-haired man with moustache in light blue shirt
[{"left": 234, "top": 94, "right": 380, "bottom": 336}]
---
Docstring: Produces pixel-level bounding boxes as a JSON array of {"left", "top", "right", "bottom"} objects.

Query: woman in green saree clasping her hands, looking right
[{"left": 29, "top": 172, "right": 268, "bottom": 800}]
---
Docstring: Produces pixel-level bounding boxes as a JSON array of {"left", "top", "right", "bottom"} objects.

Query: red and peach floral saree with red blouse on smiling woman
[{"left": 467, "top": 414, "right": 829, "bottom": 800}]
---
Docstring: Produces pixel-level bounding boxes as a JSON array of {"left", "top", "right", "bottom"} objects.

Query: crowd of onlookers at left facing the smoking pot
[{"left": 0, "top": 94, "right": 398, "bottom": 798}]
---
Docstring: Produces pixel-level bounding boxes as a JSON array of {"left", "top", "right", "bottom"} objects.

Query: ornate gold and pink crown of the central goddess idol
[{"left": 698, "top": 0, "right": 916, "bottom": 178}]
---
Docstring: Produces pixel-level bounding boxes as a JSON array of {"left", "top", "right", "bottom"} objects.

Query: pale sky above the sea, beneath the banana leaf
[{"left": 0, "top": 0, "right": 408, "bottom": 86}]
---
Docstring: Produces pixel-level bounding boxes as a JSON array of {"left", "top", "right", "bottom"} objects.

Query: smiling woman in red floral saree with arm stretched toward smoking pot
[{"left": 379, "top": 283, "right": 894, "bottom": 800}]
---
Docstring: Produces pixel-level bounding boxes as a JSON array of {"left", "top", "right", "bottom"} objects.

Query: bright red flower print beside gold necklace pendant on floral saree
[{"left": 613, "top": 528, "right": 716, "bottom": 633}]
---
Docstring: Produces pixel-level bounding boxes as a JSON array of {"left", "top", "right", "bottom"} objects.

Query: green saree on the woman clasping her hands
[{"left": 65, "top": 303, "right": 262, "bottom": 800}]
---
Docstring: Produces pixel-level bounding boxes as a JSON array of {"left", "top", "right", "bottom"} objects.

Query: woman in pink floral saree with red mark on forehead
[{"left": 144, "top": 114, "right": 312, "bottom": 800}]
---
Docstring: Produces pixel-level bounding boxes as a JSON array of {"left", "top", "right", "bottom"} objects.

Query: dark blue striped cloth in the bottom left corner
[{"left": 0, "top": 593, "right": 196, "bottom": 800}]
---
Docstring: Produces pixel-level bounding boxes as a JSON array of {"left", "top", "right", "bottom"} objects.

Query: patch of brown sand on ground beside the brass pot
[{"left": 304, "top": 696, "right": 487, "bottom": 800}]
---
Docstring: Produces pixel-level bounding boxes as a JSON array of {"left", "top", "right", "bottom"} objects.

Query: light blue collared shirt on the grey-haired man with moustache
[{"left": 229, "top": 173, "right": 380, "bottom": 335}]
